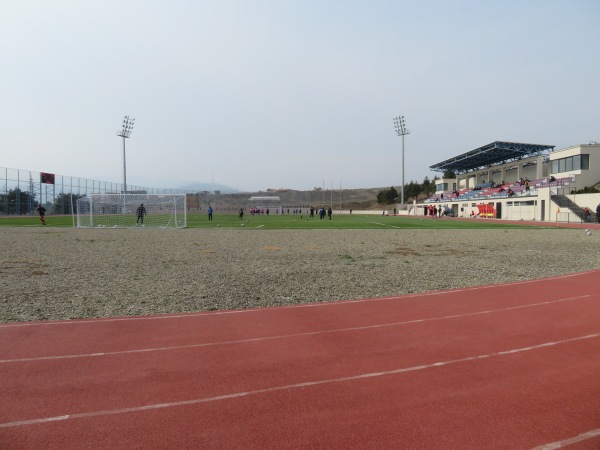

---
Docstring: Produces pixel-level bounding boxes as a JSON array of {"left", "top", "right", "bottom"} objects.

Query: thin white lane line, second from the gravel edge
[{"left": 0, "top": 294, "right": 591, "bottom": 364}]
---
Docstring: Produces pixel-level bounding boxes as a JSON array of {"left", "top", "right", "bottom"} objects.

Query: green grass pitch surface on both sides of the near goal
[{"left": 0, "top": 214, "right": 540, "bottom": 230}]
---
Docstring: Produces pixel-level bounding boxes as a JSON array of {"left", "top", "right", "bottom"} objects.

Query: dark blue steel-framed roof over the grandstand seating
[{"left": 429, "top": 141, "right": 555, "bottom": 173}]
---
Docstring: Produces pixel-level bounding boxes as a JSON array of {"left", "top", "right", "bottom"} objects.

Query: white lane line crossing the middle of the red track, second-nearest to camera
[{"left": 0, "top": 333, "right": 600, "bottom": 428}]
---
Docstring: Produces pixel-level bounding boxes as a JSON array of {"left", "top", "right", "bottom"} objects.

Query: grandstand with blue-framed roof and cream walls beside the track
[{"left": 422, "top": 141, "right": 600, "bottom": 221}]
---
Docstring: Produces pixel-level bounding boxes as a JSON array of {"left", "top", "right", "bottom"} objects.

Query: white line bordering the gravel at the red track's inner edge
[{"left": 0, "top": 269, "right": 600, "bottom": 329}]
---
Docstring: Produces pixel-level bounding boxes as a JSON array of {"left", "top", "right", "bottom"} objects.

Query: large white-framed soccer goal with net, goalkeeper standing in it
[{"left": 77, "top": 194, "right": 187, "bottom": 228}]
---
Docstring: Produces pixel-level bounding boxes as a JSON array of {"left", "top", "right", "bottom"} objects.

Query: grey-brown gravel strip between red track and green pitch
[{"left": 0, "top": 227, "right": 600, "bottom": 322}]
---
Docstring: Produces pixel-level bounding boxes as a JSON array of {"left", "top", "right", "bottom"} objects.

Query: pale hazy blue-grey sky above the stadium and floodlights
[{"left": 0, "top": 0, "right": 600, "bottom": 191}]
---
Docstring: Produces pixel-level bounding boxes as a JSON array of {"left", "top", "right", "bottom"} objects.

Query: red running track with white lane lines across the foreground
[{"left": 0, "top": 271, "right": 600, "bottom": 450}]
